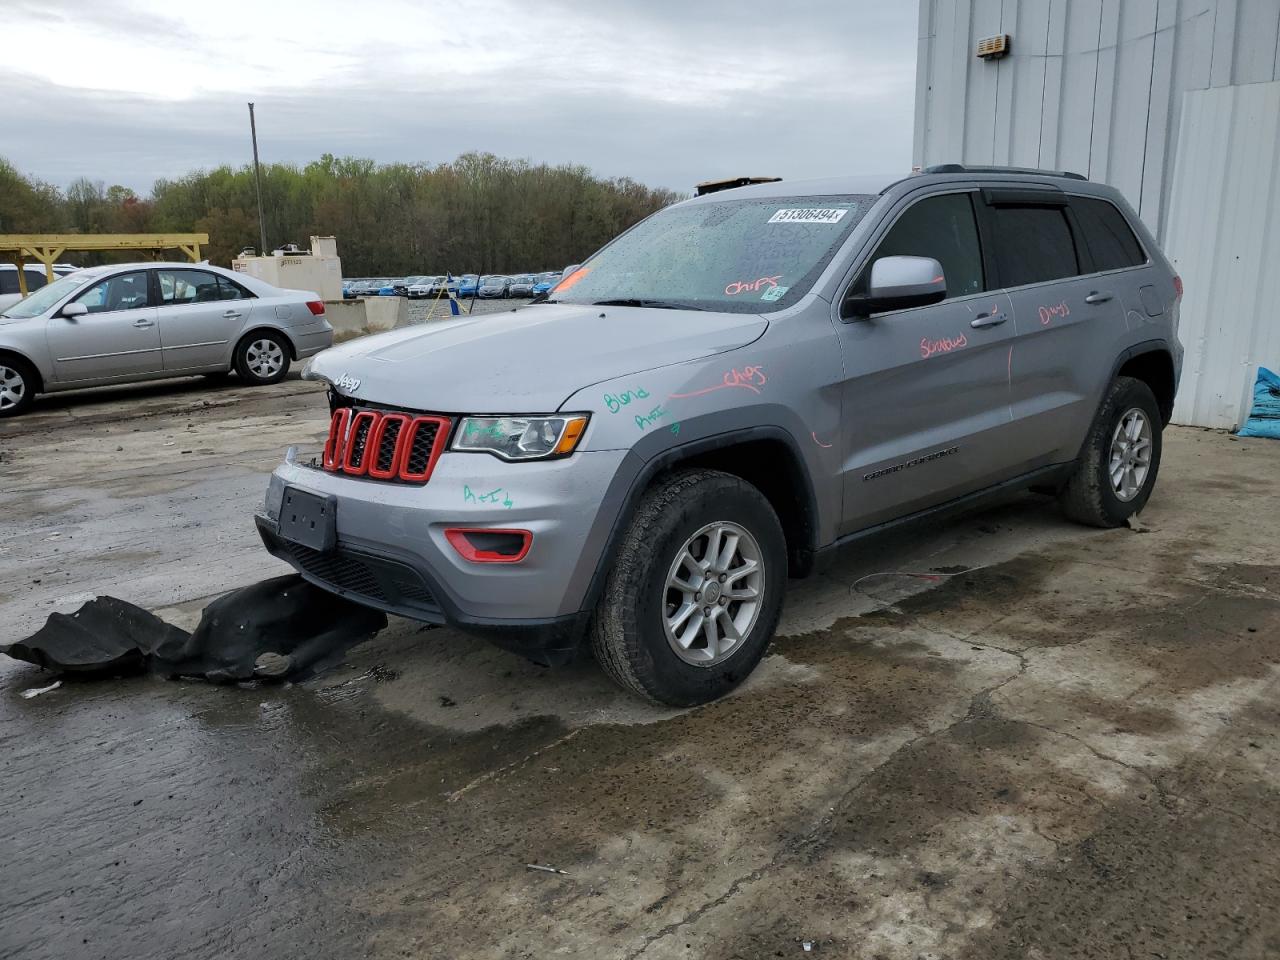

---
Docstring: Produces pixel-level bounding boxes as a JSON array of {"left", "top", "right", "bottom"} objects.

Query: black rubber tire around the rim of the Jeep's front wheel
[{"left": 591, "top": 470, "right": 787, "bottom": 707}]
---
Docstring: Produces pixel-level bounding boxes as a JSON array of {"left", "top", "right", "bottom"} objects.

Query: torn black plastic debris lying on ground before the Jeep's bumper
[{"left": 0, "top": 575, "right": 387, "bottom": 684}]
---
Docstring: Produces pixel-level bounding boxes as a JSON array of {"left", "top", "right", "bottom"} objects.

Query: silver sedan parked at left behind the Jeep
[{"left": 0, "top": 264, "right": 333, "bottom": 417}]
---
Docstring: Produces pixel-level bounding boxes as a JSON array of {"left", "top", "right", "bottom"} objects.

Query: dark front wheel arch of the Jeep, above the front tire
[{"left": 582, "top": 426, "right": 818, "bottom": 609}]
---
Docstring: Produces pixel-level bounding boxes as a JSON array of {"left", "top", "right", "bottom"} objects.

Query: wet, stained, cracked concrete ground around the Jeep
[{"left": 0, "top": 371, "right": 1280, "bottom": 960}]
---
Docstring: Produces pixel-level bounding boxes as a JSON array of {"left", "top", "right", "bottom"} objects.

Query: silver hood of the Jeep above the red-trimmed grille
[{"left": 307, "top": 303, "right": 768, "bottom": 413}]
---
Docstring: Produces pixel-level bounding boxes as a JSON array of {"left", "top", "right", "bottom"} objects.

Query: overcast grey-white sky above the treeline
[{"left": 0, "top": 0, "right": 918, "bottom": 193}]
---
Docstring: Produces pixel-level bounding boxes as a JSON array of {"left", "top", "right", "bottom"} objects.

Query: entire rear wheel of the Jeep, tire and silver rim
[{"left": 1059, "top": 376, "right": 1162, "bottom": 527}]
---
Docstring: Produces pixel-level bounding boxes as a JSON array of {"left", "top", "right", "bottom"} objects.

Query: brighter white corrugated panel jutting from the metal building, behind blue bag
[{"left": 1165, "top": 83, "right": 1280, "bottom": 429}]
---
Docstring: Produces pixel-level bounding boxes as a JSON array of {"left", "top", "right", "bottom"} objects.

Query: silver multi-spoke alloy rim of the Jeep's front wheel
[{"left": 663, "top": 521, "right": 764, "bottom": 667}]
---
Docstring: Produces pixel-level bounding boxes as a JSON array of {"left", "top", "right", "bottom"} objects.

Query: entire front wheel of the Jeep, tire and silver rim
[{"left": 591, "top": 470, "right": 787, "bottom": 707}]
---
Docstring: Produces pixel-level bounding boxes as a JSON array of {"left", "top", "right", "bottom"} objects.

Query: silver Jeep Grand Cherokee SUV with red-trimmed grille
[{"left": 257, "top": 165, "right": 1181, "bottom": 705}]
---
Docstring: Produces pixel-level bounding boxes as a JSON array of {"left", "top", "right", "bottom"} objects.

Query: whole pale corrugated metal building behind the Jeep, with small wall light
[{"left": 914, "top": 0, "right": 1280, "bottom": 428}]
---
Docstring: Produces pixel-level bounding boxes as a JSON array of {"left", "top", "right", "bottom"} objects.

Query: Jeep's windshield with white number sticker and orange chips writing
[{"left": 550, "top": 196, "right": 876, "bottom": 314}]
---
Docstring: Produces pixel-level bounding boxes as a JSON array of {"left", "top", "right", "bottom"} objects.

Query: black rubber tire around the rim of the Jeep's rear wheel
[{"left": 1059, "top": 376, "right": 1162, "bottom": 527}]
